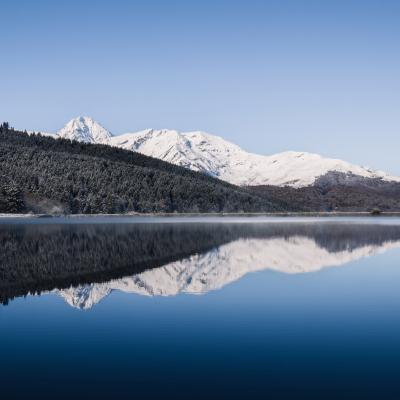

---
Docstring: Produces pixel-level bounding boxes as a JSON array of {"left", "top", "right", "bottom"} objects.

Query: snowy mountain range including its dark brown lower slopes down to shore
[{"left": 12, "top": 117, "right": 400, "bottom": 212}]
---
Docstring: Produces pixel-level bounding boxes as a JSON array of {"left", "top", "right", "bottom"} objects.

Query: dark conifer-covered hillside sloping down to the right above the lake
[{"left": 0, "top": 123, "right": 281, "bottom": 214}]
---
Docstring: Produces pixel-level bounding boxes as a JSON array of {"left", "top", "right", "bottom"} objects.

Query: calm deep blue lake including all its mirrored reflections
[{"left": 0, "top": 218, "right": 400, "bottom": 399}]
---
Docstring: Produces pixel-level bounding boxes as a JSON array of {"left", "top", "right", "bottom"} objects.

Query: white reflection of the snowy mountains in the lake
[{"left": 55, "top": 236, "right": 400, "bottom": 309}]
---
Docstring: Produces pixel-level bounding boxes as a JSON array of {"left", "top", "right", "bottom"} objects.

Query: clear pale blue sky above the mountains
[{"left": 0, "top": 0, "right": 400, "bottom": 174}]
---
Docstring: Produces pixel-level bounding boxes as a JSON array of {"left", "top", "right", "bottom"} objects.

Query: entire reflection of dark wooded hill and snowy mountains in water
[{"left": 0, "top": 222, "right": 400, "bottom": 309}]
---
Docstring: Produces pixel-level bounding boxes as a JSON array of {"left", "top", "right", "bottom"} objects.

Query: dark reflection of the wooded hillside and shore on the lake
[{"left": 0, "top": 221, "right": 400, "bottom": 304}]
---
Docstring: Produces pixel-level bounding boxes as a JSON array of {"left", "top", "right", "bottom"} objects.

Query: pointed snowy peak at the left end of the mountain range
[{"left": 58, "top": 116, "right": 113, "bottom": 144}]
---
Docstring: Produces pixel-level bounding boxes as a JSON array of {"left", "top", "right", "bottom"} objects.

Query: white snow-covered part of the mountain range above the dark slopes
[{"left": 38, "top": 117, "right": 400, "bottom": 188}]
